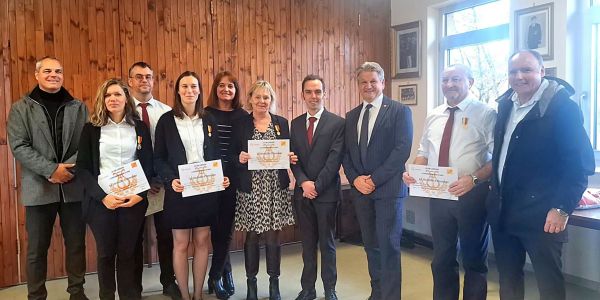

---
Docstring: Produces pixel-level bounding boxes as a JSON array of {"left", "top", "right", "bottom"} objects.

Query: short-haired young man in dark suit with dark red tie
[{"left": 290, "top": 75, "right": 344, "bottom": 300}]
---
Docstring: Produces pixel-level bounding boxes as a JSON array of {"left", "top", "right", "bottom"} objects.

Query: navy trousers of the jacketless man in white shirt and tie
[{"left": 429, "top": 184, "right": 489, "bottom": 300}]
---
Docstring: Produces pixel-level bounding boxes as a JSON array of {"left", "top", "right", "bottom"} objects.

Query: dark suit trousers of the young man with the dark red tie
[{"left": 295, "top": 196, "right": 337, "bottom": 290}]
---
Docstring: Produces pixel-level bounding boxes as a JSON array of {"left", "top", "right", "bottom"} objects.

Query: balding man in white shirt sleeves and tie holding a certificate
[{"left": 403, "top": 64, "right": 496, "bottom": 300}]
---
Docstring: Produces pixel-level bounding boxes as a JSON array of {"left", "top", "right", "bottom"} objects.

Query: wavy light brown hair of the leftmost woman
[{"left": 90, "top": 78, "right": 140, "bottom": 127}]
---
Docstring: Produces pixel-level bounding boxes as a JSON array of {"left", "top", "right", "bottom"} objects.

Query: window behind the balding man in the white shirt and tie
[{"left": 439, "top": 0, "right": 508, "bottom": 104}]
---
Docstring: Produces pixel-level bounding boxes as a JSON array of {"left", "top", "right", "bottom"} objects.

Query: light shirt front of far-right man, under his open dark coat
[{"left": 498, "top": 79, "right": 548, "bottom": 182}]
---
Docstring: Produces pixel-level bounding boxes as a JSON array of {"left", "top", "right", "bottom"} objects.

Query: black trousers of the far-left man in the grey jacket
[{"left": 25, "top": 202, "right": 85, "bottom": 299}]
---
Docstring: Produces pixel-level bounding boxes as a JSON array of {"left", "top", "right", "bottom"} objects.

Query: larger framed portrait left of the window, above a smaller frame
[{"left": 392, "top": 21, "right": 421, "bottom": 79}]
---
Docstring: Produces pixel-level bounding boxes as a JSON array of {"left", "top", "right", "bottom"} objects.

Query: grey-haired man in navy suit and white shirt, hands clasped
[{"left": 343, "top": 62, "right": 412, "bottom": 300}]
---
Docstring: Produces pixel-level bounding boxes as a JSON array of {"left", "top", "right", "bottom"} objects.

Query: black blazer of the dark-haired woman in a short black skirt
[{"left": 154, "top": 111, "right": 219, "bottom": 185}]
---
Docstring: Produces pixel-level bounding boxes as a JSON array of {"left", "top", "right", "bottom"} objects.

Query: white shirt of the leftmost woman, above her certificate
[{"left": 100, "top": 118, "right": 137, "bottom": 175}]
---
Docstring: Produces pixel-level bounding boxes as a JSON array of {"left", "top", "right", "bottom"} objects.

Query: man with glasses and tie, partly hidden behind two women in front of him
[{"left": 128, "top": 61, "right": 181, "bottom": 298}]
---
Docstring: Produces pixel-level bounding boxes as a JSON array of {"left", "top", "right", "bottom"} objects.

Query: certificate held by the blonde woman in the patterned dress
[{"left": 248, "top": 139, "right": 290, "bottom": 170}]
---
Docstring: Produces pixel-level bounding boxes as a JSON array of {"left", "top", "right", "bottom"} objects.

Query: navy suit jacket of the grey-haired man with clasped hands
[{"left": 343, "top": 96, "right": 413, "bottom": 198}]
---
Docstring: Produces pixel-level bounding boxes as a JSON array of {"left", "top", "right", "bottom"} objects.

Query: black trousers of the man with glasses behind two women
[{"left": 135, "top": 211, "right": 175, "bottom": 288}]
